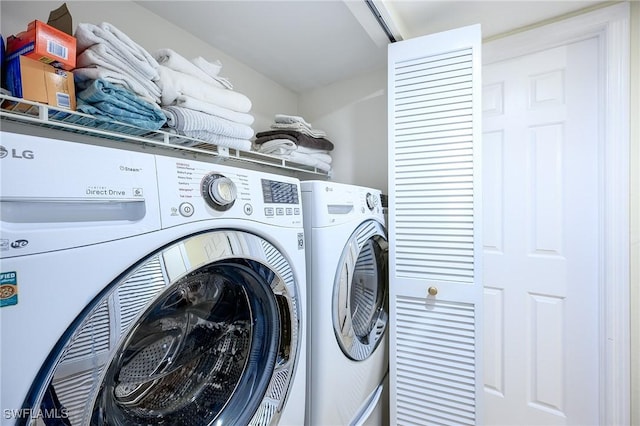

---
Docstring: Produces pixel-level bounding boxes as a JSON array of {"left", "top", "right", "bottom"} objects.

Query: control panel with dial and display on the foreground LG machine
[{"left": 156, "top": 156, "right": 303, "bottom": 228}]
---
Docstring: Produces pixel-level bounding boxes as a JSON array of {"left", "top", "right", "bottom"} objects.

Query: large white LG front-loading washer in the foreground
[{"left": 0, "top": 132, "right": 306, "bottom": 426}]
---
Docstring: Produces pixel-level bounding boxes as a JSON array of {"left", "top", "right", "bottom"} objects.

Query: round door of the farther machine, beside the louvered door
[{"left": 332, "top": 221, "right": 388, "bottom": 361}]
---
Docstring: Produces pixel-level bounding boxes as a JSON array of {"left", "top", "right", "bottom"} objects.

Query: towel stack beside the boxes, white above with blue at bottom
[{"left": 73, "top": 23, "right": 166, "bottom": 130}]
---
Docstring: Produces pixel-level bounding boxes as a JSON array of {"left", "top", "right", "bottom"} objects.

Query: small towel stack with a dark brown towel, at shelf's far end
[{"left": 254, "top": 114, "right": 333, "bottom": 172}]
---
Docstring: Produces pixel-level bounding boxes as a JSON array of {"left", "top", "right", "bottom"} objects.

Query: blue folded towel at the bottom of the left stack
[{"left": 77, "top": 79, "right": 167, "bottom": 130}]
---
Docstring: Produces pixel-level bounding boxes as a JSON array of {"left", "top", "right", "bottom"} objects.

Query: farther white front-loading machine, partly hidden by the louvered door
[{"left": 301, "top": 181, "right": 388, "bottom": 426}]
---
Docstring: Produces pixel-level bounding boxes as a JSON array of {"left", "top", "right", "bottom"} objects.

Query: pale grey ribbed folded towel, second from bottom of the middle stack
[{"left": 162, "top": 106, "right": 254, "bottom": 139}]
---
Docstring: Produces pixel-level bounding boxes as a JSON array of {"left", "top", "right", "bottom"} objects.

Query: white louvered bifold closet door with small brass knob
[{"left": 388, "top": 25, "right": 483, "bottom": 425}]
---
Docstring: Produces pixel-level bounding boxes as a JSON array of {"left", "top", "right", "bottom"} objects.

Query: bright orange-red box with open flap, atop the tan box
[{"left": 6, "top": 20, "right": 76, "bottom": 70}]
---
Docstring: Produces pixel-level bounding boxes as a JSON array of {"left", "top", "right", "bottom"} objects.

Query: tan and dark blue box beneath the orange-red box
[{"left": 7, "top": 55, "right": 76, "bottom": 111}]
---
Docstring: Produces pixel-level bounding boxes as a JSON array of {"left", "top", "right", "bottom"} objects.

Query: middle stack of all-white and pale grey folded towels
[{"left": 153, "top": 49, "right": 254, "bottom": 151}]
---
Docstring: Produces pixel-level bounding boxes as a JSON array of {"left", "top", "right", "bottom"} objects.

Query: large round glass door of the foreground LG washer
[{"left": 26, "top": 230, "right": 301, "bottom": 426}]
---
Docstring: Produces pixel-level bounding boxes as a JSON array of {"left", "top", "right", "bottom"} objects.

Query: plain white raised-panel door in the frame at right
[{"left": 483, "top": 37, "right": 603, "bottom": 426}]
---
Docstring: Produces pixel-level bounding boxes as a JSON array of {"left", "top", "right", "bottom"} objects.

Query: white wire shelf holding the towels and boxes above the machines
[{"left": 0, "top": 94, "right": 329, "bottom": 177}]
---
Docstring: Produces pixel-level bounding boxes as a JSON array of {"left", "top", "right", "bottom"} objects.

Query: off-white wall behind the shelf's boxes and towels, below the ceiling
[{"left": 0, "top": 0, "right": 298, "bottom": 132}]
